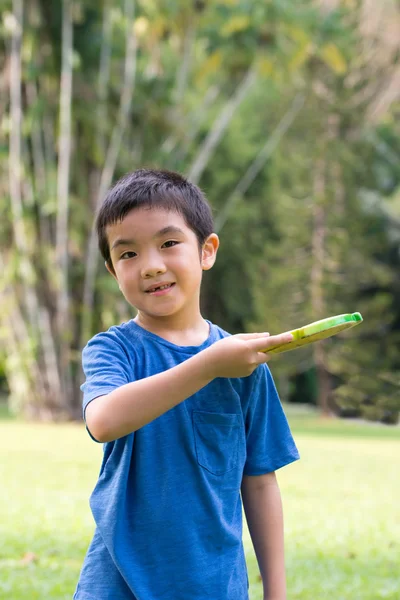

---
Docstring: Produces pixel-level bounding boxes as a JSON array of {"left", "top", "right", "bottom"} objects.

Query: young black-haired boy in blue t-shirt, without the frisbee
[{"left": 74, "top": 169, "right": 298, "bottom": 600}]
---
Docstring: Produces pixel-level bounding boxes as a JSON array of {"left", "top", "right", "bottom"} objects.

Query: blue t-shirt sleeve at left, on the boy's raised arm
[{"left": 81, "top": 330, "right": 132, "bottom": 437}]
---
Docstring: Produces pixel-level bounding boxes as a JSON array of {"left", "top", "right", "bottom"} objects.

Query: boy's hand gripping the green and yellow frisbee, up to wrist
[{"left": 204, "top": 333, "right": 293, "bottom": 378}]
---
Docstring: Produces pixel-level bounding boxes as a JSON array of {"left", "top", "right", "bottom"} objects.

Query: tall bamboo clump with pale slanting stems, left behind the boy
[{"left": 1, "top": 0, "right": 322, "bottom": 418}]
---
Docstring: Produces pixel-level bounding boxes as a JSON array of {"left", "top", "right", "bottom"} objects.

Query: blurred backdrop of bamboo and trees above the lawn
[{"left": 0, "top": 0, "right": 400, "bottom": 423}]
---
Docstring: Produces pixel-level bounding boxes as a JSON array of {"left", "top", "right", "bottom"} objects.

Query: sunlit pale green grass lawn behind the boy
[{"left": 0, "top": 408, "right": 400, "bottom": 600}]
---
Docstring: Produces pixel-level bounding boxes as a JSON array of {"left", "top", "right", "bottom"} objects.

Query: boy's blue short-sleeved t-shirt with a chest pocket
[{"left": 74, "top": 321, "right": 299, "bottom": 600}]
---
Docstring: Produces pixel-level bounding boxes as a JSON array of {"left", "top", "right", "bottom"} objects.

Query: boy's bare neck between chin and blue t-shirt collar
[{"left": 134, "top": 312, "right": 210, "bottom": 346}]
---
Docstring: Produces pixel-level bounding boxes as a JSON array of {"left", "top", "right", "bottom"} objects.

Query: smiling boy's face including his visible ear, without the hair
[{"left": 106, "top": 208, "right": 218, "bottom": 322}]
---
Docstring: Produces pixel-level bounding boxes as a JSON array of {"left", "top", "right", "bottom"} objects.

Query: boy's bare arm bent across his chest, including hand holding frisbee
[{"left": 85, "top": 333, "right": 293, "bottom": 442}]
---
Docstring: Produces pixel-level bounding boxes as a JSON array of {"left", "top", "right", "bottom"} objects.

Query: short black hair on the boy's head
[{"left": 96, "top": 169, "right": 214, "bottom": 268}]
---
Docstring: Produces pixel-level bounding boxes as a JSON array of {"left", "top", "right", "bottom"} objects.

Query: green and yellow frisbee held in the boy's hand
[{"left": 264, "top": 313, "right": 363, "bottom": 354}]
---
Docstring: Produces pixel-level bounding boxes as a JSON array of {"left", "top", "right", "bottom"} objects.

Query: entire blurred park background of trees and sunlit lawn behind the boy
[{"left": 0, "top": 0, "right": 400, "bottom": 600}]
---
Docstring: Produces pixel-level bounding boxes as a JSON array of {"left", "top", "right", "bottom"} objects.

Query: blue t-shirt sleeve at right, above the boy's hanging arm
[{"left": 244, "top": 364, "right": 300, "bottom": 475}]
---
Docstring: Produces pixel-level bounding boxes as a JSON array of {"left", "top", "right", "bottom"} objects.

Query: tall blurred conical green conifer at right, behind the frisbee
[{"left": 231, "top": 0, "right": 399, "bottom": 420}]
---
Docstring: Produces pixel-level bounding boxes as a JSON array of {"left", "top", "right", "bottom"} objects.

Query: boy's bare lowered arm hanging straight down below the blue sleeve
[{"left": 241, "top": 472, "right": 286, "bottom": 600}]
